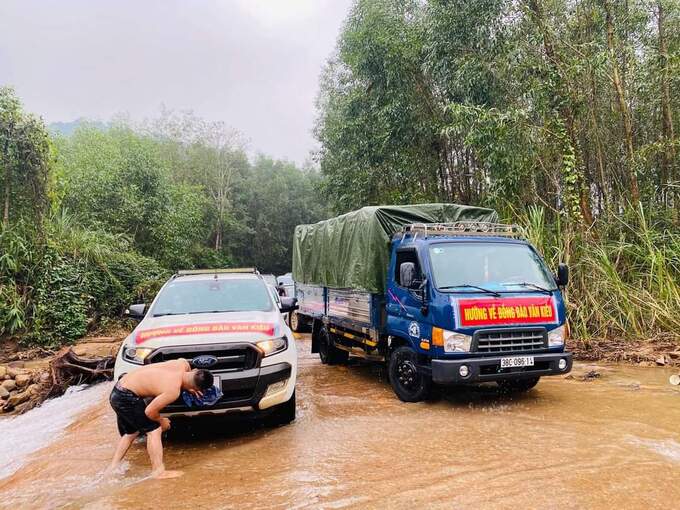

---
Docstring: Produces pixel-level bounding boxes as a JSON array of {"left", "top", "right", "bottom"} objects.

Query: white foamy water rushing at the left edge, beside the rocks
[{"left": 0, "top": 384, "right": 109, "bottom": 478}]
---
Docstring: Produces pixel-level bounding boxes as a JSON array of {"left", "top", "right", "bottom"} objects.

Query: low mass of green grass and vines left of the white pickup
[{"left": 0, "top": 212, "right": 167, "bottom": 346}]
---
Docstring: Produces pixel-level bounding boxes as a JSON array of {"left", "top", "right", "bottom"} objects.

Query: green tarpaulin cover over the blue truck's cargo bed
[{"left": 293, "top": 204, "right": 498, "bottom": 293}]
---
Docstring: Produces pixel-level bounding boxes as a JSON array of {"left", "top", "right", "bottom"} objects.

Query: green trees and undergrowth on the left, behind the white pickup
[{"left": 0, "top": 88, "right": 324, "bottom": 347}]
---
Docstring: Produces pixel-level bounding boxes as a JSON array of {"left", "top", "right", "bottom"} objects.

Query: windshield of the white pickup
[{"left": 151, "top": 278, "right": 272, "bottom": 317}]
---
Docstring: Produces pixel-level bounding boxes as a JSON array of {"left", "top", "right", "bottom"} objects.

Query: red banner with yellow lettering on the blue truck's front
[{"left": 458, "top": 296, "right": 557, "bottom": 328}]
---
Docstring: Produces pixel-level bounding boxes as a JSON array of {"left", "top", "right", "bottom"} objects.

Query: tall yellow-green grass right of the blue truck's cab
[{"left": 519, "top": 207, "right": 680, "bottom": 340}]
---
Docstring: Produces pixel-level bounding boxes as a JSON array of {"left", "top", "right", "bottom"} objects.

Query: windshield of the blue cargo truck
[{"left": 430, "top": 243, "right": 555, "bottom": 292}]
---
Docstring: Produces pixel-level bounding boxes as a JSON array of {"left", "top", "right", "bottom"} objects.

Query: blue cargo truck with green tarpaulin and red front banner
[{"left": 291, "top": 204, "right": 572, "bottom": 402}]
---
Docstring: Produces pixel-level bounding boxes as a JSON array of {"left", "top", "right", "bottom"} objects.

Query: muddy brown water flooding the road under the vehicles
[{"left": 0, "top": 336, "right": 680, "bottom": 509}]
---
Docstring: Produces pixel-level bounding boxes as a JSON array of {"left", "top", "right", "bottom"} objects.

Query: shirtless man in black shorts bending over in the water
[{"left": 108, "top": 359, "right": 213, "bottom": 478}]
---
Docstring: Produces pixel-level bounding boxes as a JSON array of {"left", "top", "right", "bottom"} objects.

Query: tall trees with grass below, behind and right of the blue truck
[{"left": 316, "top": 0, "right": 680, "bottom": 340}]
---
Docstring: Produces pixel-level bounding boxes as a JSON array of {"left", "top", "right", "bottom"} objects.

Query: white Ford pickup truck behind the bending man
[{"left": 114, "top": 269, "right": 297, "bottom": 424}]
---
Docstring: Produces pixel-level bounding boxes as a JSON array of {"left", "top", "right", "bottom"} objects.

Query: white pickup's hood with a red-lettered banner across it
[{"left": 126, "top": 311, "right": 284, "bottom": 348}]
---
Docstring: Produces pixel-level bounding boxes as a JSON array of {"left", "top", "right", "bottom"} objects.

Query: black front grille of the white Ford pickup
[{"left": 146, "top": 343, "right": 261, "bottom": 372}]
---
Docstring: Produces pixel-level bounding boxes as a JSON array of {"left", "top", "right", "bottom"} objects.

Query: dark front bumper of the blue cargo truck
[{"left": 431, "top": 352, "right": 572, "bottom": 384}]
